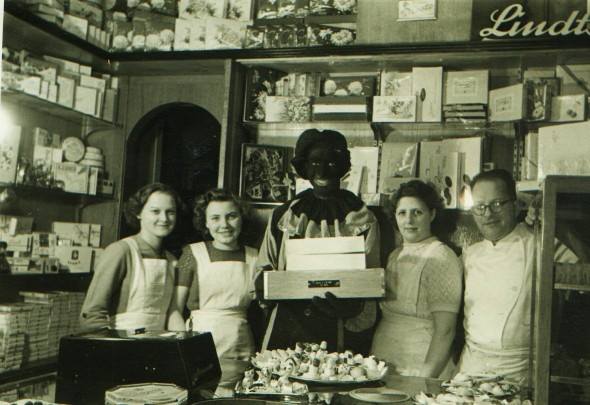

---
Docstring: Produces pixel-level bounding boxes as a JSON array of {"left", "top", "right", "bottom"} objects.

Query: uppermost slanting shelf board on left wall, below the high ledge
[{"left": 2, "top": 90, "right": 119, "bottom": 129}]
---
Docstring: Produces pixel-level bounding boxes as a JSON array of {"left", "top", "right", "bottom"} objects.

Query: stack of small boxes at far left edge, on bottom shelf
[{"left": 0, "top": 303, "right": 31, "bottom": 372}]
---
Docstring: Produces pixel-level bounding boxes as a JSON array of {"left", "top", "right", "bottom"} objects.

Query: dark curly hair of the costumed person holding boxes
[{"left": 291, "top": 128, "right": 351, "bottom": 180}]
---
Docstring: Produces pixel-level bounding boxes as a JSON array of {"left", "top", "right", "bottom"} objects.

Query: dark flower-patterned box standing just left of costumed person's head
[{"left": 240, "top": 144, "right": 291, "bottom": 203}]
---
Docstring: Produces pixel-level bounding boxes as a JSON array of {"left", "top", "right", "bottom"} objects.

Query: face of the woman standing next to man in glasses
[{"left": 395, "top": 197, "right": 436, "bottom": 243}]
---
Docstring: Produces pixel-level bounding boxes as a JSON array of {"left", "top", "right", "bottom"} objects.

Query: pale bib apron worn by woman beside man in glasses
[{"left": 372, "top": 241, "right": 453, "bottom": 378}]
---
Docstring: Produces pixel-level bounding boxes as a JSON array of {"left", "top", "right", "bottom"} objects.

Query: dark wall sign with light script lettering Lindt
[{"left": 472, "top": 1, "right": 590, "bottom": 40}]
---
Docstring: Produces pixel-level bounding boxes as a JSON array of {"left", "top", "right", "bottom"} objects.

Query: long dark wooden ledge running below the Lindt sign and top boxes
[{"left": 4, "top": 2, "right": 590, "bottom": 74}]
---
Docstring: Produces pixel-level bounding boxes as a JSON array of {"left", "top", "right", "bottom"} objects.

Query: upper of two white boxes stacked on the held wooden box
[{"left": 285, "top": 236, "right": 365, "bottom": 255}]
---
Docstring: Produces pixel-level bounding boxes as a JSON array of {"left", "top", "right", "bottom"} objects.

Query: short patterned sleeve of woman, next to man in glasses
[{"left": 420, "top": 248, "right": 463, "bottom": 313}]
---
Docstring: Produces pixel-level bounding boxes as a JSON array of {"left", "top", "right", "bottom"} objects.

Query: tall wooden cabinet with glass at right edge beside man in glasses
[{"left": 531, "top": 176, "right": 590, "bottom": 405}]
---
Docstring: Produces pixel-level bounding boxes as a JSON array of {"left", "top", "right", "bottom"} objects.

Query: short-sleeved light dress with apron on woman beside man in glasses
[{"left": 371, "top": 237, "right": 462, "bottom": 378}]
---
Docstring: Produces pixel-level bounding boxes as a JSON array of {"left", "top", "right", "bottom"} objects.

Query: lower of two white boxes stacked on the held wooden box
[{"left": 287, "top": 252, "right": 367, "bottom": 271}]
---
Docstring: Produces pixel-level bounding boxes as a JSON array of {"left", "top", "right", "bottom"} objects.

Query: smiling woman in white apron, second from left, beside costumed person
[{"left": 171, "top": 189, "right": 258, "bottom": 360}]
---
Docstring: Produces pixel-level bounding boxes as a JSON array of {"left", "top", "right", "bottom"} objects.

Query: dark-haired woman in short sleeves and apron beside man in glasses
[{"left": 372, "top": 180, "right": 462, "bottom": 378}]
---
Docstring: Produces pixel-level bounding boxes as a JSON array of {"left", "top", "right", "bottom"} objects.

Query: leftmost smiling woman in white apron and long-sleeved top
[{"left": 81, "top": 183, "right": 182, "bottom": 330}]
